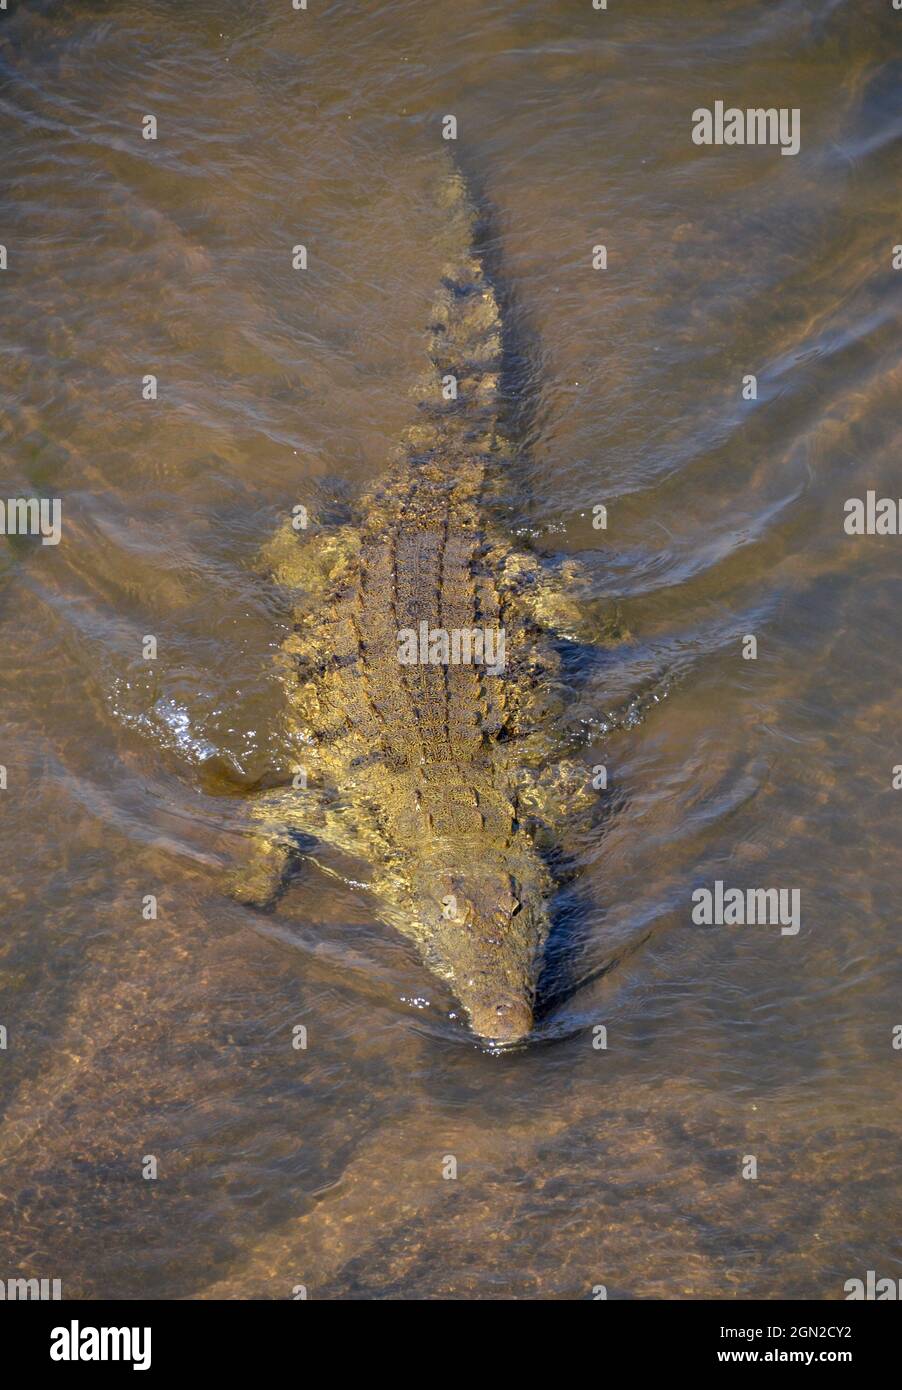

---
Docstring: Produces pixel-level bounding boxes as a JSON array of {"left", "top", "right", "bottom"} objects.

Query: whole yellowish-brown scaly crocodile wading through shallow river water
[{"left": 232, "top": 162, "right": 619, "bottom": 1048}]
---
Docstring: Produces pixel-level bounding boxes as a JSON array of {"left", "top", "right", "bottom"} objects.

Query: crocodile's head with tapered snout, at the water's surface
[{"left": 417, "top": 867, "right": 548, "bottom": 1045}]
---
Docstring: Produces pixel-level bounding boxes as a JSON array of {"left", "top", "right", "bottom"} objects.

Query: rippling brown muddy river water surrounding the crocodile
[{"left": 0, "top": 0, "right": 902, "bottom": 1300}]
